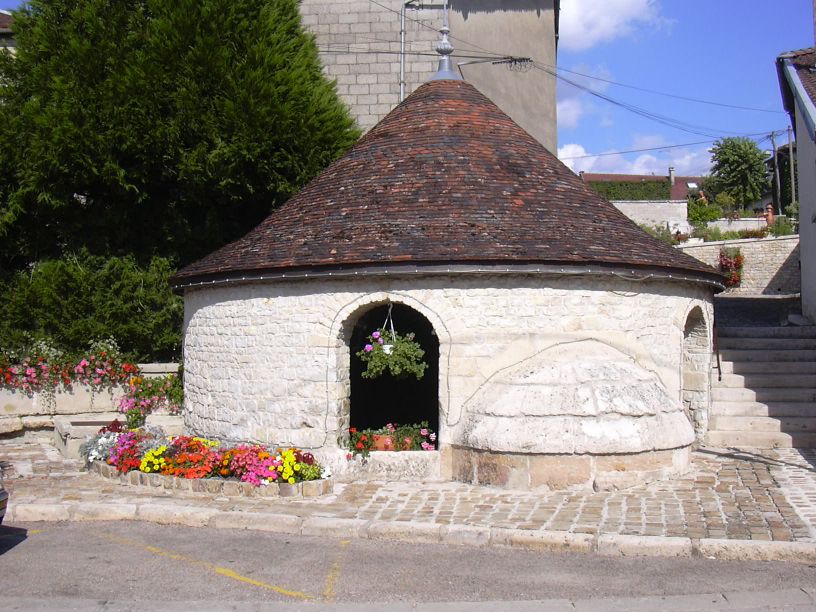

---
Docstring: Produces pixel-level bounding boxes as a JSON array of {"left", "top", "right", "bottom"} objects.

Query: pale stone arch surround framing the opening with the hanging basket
[{"left": 327, "top": 292, "right": 451, "bottom": 448}]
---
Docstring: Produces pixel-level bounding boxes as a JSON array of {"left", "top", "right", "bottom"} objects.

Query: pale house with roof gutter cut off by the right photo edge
[{"left": 776, "top": 47, "right": 816, "bottom": 321}]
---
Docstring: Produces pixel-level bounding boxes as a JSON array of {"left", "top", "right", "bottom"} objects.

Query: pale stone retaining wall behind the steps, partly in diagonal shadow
[{"left": 677, "top": 236, "right": 801, "bottom": 295}]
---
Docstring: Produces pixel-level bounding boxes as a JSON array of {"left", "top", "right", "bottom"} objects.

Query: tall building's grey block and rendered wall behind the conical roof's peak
[{"left": 301, "top": 0, "right": 557, "bottom": 153}]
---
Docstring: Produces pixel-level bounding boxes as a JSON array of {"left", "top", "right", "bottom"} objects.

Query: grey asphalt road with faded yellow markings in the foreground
[{"left": 0, "top": 521, "right": 816, "bottom": 610}]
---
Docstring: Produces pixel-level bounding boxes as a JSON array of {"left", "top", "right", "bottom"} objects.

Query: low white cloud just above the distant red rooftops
[{"left": 558, "top": 136, "right": 711, "bottom": 176}]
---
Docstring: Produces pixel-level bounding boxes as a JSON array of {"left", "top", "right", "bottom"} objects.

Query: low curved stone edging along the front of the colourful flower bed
[{"left": 89, "top": 461, "right": 334, "bottom": 498}]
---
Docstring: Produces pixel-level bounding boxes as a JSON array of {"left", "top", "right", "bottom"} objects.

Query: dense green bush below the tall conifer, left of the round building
[{"left": 0, "top": 251, "right": 183, "bottom": 361}]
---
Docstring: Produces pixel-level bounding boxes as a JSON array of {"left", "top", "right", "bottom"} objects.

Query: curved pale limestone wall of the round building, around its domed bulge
[{"left": 184, "top": 275, "right": 712, "bottom": 462}]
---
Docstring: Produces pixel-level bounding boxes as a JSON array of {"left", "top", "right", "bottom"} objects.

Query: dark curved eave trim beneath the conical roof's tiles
[{"left": 170, "top": 263, "right": 725, "bottom": 293}]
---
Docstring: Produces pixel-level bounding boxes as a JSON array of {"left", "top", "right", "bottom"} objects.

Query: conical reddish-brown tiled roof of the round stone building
[{"left": 174, "top": 80, "right": 722, "bottom": 286}]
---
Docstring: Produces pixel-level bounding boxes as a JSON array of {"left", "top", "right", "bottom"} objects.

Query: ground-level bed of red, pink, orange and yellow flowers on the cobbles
[{"left": 80, "top": 420, "right": 330, "bottom": 496}]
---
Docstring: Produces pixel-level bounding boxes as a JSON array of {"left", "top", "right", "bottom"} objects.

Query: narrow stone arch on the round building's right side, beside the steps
[{"left": 680, "top": 305, "right": 711, "bottom": 444}]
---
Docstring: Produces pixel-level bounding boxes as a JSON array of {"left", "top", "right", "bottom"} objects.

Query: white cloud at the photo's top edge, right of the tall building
[{"left": 558, "top": 0, "right": 669, "bottom": 51}]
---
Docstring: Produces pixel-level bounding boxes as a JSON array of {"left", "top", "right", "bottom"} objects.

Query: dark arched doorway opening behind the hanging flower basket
[{"left": 349, "top": 303, "right": 439, "bottom": 432}]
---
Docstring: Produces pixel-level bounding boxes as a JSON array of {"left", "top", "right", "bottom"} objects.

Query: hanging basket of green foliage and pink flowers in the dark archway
[{"left": 357, "top": 329, "right": 428, "bottom": 380}]
